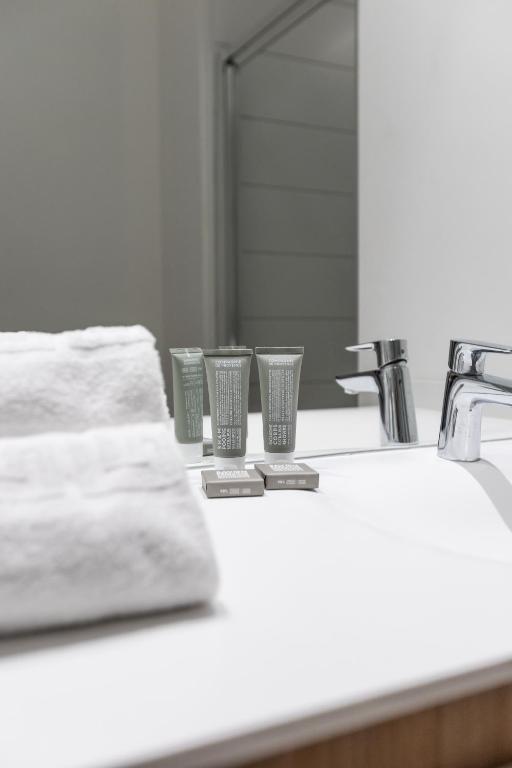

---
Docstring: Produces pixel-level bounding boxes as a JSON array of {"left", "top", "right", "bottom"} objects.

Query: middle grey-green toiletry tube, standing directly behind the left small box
[{"left": 203, "top": 349, "right": 252, "bottom": 469}]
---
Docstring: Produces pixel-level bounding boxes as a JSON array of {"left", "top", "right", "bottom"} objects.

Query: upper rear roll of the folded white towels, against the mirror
[{"left": 0, "top": 325, "right": 169, "bottom": 437}]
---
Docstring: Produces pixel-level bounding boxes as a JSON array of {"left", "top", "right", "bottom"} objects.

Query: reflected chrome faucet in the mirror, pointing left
[{"left": 336, "top": 339, "right": 418, "bottom": 445}]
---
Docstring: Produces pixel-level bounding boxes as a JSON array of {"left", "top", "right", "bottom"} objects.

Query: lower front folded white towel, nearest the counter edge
[{"left": 0, "top": 424, "right": 217, "bottom": 634}]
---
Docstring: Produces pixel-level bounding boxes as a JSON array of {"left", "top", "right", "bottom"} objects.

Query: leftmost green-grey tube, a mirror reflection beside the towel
[{"left": 169, "top": 347, "right": 203, "bottom": 462}]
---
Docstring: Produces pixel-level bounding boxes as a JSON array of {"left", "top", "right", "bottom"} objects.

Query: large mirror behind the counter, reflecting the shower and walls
[{"left": 0, "top": 0, "right": 512, "bottom": 462}]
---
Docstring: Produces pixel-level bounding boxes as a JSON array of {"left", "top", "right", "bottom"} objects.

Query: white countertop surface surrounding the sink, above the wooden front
[{"left": 0, "top": 426, "right": 512, "bottom": 768}]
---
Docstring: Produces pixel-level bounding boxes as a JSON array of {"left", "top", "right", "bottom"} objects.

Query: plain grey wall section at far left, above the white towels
[{"left": 0, "top": 0, "right": 162, "bottom": 335}]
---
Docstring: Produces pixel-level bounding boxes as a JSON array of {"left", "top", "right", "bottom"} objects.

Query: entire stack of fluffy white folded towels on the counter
[{"left": 0, "top": 326, "right": 217, "bottom": 634}]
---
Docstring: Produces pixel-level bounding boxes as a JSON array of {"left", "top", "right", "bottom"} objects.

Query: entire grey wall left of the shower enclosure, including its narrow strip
[{"left": 0, "top": 0, "right": 286, "bottom": 408}]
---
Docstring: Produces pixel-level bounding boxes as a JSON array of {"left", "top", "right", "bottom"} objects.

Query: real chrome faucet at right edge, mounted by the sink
[{"left": 437, "top": 339, "right": 512, "bottom": 461}]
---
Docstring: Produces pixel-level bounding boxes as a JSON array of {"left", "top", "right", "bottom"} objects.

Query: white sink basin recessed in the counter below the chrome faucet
[{"left": 315, "top": 440, "right": 512, "bottom": 563}]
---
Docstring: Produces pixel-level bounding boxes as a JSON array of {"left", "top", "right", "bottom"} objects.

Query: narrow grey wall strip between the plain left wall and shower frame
[{"left": 159, "top": 0, "right": 215, "bottom": 356}]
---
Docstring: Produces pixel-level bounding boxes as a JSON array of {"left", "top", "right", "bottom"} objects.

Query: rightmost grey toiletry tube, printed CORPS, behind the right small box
[{"left": 256, "top": 347, "right": 304, "bottom": 464}]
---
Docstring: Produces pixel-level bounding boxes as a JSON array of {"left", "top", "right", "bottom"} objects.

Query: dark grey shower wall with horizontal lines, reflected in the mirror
[{"left": 237, "top": 0, "right": 357, "bottom": 408}]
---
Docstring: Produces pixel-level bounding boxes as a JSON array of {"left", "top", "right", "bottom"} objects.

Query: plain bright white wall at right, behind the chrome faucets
[{"left": 359, "top": 0, "right": 512, "bottom": 406}]
